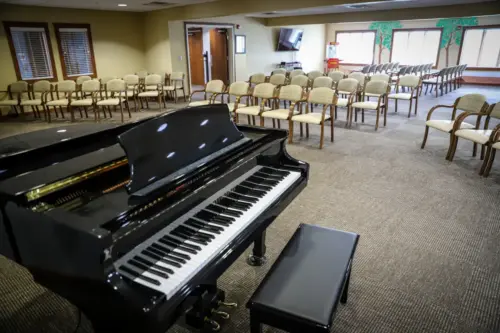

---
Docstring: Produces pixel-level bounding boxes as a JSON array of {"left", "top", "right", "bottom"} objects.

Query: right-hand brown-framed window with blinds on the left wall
[{"left": 54, "top": 24, "right": 96, "bottom": 79}]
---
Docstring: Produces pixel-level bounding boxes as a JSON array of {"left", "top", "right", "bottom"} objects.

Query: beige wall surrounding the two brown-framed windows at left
[{"left": 0, "top": 5, "right": 146, "bottom": 90}]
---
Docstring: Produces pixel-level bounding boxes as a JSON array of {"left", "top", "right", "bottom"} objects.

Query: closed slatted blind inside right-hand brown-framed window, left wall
[{"left": 58, "top": 28, "right": 94, "bottom": 77}]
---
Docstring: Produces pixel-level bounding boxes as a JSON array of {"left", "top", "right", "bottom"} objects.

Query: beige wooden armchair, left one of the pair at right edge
[{"left": 421, "top": 94, "right": 488, "bottom": 151}]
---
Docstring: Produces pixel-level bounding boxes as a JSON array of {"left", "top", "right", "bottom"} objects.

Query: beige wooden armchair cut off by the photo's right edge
[{"left": 448, "top": 103, "right": 500, "bottom": 161}]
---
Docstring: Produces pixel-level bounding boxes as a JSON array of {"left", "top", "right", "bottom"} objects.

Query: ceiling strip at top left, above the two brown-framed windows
[{"left": 0, "top": 0, "right": 216, "bottom": 12}]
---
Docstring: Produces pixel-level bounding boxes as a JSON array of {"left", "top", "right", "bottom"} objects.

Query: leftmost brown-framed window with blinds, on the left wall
[{"left": 4, "top": 22, "right": 55, "bottom": 81}]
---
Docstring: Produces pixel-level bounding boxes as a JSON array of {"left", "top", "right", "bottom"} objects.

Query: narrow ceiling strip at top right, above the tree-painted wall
[{"left": 247, "top": 0, "right": 496, "bottom": 17}]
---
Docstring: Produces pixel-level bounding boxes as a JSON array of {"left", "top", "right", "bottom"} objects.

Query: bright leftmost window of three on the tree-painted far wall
[{"left": 335, "top": 30, "right": 376, "bottom": 65}]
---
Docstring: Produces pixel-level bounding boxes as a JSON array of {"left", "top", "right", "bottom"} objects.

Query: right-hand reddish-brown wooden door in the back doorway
[{"left": 210, "top": 28, "right": 229, "bottom": 83}]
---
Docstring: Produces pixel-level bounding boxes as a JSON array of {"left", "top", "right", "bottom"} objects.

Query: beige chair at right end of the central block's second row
[{"left": 349, "top": 81, "right": 391, "bottom": 130}]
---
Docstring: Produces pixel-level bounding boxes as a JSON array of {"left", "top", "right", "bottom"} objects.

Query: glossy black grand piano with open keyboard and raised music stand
[{"left": 0, "top": 105, "right": 309, "bottom": 332}]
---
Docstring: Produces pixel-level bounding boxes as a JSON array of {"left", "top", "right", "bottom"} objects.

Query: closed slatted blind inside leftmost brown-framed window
[{"left": 10, "top": 27, "right": 54, "bottom": 80}]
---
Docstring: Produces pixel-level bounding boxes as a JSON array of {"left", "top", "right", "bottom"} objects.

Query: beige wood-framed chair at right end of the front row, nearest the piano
[{"left": 288, "top": 87, "right": 337, "bottom": 149}]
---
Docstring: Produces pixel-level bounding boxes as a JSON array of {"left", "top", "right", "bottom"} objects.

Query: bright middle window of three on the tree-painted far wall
[{"left": 391, "top": 28, "right": 442, "bottom": 66}]
